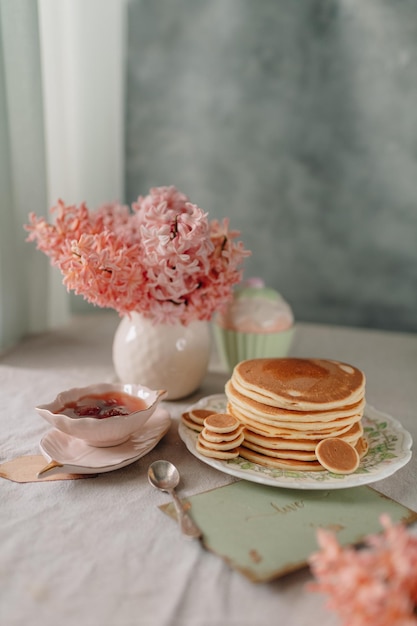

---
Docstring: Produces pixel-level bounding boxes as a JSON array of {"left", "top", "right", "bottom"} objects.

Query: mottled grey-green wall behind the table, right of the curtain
[{"left": 126, "top": 0, "right": 417, "bottom": 331}]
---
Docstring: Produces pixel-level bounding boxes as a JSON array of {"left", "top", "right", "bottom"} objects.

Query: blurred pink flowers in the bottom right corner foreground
[{"left": 308, "top": 515, "right": 417, "bottom": 626}]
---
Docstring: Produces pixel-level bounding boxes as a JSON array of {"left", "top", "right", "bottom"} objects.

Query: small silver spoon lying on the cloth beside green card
[{"left": 148, "top": 461, "right": 201, "bottom": 537}]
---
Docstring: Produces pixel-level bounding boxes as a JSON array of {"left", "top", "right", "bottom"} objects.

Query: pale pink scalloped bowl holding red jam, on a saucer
[{"left": 35, "top": 383, "right": 167, "bottom": 448}]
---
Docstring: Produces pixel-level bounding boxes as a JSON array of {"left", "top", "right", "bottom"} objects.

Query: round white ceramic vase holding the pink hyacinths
[{"left": 113, "top": 313, "right": 211, "bottom": 400}]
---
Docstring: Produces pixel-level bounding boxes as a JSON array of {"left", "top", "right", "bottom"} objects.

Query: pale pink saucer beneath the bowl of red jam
[{"left": 40, "top": 407, "right": 171, "bottom": 475}]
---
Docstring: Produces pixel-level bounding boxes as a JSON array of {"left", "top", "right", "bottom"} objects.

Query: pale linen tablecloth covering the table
[{"left": 0, "top": 313, "right": 417, "bottom": 626}]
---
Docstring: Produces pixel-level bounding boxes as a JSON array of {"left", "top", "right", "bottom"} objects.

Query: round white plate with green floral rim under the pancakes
[{"left": 178, "top": 394, "right": 412, "bottom": 489}]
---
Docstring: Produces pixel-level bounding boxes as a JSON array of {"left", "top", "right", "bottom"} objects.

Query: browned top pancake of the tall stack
[{"left": 232, "top": 358, "right": 365, "bottom": 411}]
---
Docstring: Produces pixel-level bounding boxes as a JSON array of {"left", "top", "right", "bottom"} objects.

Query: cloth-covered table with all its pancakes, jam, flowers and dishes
[{"left": 0, "top": 186, "right": 417, "bottom": 626}]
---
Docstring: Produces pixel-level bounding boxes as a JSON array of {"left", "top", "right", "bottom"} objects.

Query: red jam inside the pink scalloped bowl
[{"left": 54, "top": 392, "right": 147, "bottom": 419}]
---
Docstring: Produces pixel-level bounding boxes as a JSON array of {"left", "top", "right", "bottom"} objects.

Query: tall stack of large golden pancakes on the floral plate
[{"left": 225, "top": 358, "right": 367, "bottom": 471}]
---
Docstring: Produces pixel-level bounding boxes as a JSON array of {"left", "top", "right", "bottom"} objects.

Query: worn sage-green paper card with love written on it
[{"left": 160, "top": 480, "right": 417, "bottom": 582}]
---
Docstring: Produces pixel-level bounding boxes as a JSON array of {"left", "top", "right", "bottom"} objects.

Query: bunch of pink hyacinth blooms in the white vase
[{"left": 25, "top": 186, "right": 250, "bottom": 325}]
